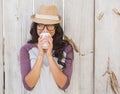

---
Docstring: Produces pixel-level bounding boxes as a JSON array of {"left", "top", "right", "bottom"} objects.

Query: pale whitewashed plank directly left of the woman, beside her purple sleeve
[{"left": 4, "top": 0, "right": 32, "bottom": 94}]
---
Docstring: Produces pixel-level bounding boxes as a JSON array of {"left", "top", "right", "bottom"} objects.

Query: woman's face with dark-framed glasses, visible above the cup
[{"left": 37, "top": 24, "right": 55, "bottom": 36}]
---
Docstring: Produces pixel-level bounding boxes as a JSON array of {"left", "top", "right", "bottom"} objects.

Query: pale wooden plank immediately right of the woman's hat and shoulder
[{"left": 64, "top": 0, "right": 94, "bottom": 94}]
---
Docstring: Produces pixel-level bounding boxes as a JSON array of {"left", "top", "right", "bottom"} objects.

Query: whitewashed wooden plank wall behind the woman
[{"left": 0, "top": 0, "right": 120, "bottom": 94}]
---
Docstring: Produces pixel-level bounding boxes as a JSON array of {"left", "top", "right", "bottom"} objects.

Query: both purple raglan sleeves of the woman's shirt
[{"left": 20, "top": 43, "right": 74, "bottom": 90}]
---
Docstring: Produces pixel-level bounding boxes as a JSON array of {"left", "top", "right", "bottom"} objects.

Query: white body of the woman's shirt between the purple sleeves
[{"left": 27, "top": 47, "right": 65, "bottom": 94}]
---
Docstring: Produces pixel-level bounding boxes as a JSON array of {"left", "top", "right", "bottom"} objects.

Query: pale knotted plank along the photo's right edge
[{"left": 95, "top": 0, "right": 120, "bottom": 94}]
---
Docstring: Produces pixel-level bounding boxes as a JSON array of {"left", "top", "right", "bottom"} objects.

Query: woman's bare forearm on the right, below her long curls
[{"left": 48, "top": 56, "right": 67, "bottom": 88}]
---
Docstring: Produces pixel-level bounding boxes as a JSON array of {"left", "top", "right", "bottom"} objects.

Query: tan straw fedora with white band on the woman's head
[{"left": 31, "top": 5, "right": 61, "bottom": 24}]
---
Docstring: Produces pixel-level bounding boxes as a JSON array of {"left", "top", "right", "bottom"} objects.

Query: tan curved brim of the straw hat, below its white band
[{"left": 31, "top": 15, "right": 62, "bottom": 24}]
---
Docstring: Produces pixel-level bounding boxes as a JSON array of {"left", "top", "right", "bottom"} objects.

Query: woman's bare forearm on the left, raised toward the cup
[{"left": 25, "top": 56, "right": 42, "bottom": 88}]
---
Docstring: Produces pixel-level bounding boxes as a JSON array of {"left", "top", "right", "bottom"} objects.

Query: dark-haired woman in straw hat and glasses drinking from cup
[{"left": 20, "top": 5, "right": 74, "bottom": 94}]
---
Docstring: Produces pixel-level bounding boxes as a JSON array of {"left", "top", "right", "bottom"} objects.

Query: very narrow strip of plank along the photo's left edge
[{"left": 0, "top": 0, "right": 3, "bottom": 94}]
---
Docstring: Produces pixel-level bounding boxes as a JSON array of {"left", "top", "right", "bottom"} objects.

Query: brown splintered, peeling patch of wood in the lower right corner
[{"left": 103, "top": 57, "right": 120, "bottom": 94}]
